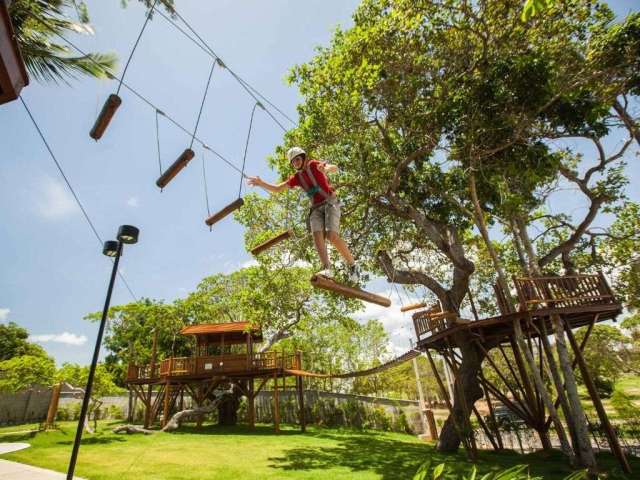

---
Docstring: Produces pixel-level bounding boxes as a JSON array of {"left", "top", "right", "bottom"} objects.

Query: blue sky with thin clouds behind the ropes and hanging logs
[{"left": 0, "top": 0, "right": 640, "bottom": 363}]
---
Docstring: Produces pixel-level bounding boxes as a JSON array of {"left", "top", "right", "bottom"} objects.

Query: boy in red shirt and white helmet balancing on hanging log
[{"left": 248, "top": 147, "right": 360, "bottom": 283}]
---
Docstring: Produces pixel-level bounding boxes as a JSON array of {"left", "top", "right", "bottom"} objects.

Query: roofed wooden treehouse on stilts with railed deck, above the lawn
[{"left": 126, "top": 322, "right": 305, "bottom": 431}]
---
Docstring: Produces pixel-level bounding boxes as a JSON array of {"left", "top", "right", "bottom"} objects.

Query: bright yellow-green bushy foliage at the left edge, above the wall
[{"left": 0, "top": 355, "right": 55, "bottom": 393}]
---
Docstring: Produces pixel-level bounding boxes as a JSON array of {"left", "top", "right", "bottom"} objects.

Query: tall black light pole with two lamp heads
[{"left": 67, "top": 225, "right": 140, "bottom": 480}]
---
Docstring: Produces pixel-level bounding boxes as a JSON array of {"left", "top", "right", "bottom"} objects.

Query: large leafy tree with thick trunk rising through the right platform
[{"left": 255, "top": 0, "right": 639, "bottom": 463}]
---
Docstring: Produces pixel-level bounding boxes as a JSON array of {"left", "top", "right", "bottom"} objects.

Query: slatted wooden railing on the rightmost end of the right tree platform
[{"left": 513, "top": 273, "right": 616, "bottom": 311}]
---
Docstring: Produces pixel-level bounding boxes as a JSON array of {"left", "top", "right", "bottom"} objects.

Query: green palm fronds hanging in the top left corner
[{"left": 9, "top": 0, "right": 117, "bottom": 83}]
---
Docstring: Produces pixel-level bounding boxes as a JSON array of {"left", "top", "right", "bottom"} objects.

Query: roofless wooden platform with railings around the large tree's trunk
[{"left": 413, "top": 275, "right": 622, "bottom": 350}]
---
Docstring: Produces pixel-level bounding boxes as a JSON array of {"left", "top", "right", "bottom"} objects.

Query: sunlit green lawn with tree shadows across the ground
[{"left": 0, "top": 422, "right": 640, "bottom": 480}]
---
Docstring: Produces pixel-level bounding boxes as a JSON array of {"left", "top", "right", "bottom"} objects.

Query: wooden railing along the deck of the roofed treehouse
[{"left": 127, "top": 352, "right": 302, "bottom": 381}]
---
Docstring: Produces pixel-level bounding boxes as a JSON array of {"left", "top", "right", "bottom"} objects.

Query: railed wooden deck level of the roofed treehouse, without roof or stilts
[{"left": 126, "top": 352, "right": 302, "bottom": 384}]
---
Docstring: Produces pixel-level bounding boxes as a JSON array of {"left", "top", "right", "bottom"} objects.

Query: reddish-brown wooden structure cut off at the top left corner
[{"left": 0, "top": 0, "right": 29, "bottom": 105}]
